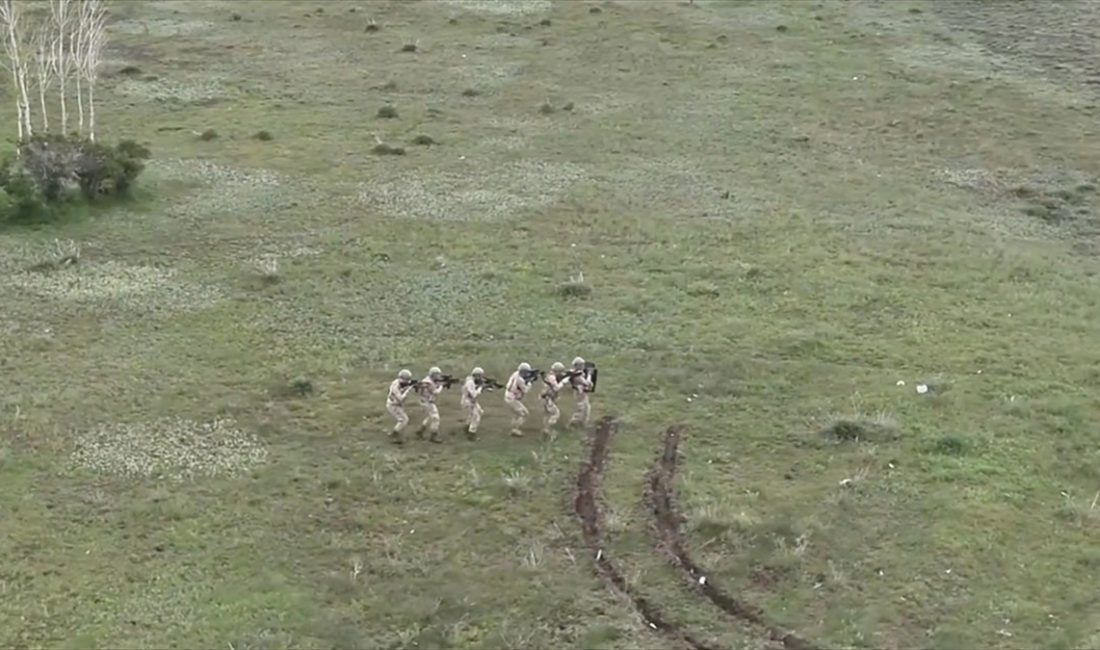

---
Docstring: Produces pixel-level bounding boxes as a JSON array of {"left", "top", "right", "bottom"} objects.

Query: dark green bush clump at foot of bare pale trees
[{"left": 0, "top": 135, "right": 150, "bottom": 221}]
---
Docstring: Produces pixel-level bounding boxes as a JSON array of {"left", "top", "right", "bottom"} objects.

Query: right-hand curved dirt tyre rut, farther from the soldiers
[{"left": 646, "top": 426, "right": 816, "bottom": 650}]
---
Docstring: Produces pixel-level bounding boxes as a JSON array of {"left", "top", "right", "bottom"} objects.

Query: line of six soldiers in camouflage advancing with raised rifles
[{"left": 386, "top": 356, "right": 595, "bottom": 444}]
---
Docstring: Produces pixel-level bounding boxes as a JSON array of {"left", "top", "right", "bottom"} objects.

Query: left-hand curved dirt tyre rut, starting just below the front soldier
[{"left": 573, "top": 418, "right": 713, "bottom": 650}]
